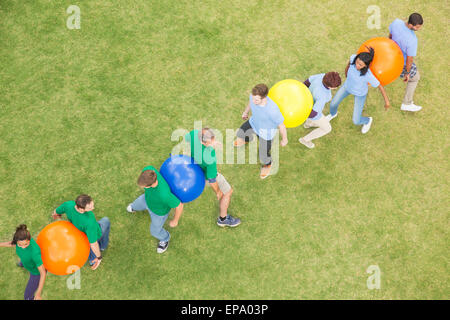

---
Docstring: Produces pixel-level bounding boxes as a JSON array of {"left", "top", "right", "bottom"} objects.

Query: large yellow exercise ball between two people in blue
[{"left": 268, "top": 79, "right": 314, "bottom": 128}]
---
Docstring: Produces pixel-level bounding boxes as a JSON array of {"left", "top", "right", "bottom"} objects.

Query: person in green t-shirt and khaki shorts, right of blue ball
[{"left": 185, "top": 128, "right": 241, "bottom": 227}]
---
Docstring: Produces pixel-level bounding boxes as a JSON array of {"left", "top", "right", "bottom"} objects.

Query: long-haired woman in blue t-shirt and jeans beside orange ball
[{"left": 327, "top": 48, "right": 390, "bottom": 133}]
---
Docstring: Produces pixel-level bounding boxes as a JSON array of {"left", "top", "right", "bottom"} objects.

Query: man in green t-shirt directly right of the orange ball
[{"left": 52, "top": 194, "right": 111, "bottom": 270}]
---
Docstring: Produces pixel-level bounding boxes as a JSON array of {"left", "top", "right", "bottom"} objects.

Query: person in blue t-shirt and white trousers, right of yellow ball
[{"left": 298, "top": 72, "right": 341, "bottom": 149}]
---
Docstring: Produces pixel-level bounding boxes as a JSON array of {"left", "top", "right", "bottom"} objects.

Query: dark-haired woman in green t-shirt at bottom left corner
[{"left": 0, "top": 224, "right": 47, "bottom": 300}]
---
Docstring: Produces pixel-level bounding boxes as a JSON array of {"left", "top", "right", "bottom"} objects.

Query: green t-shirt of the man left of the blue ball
[{"left": 142, "top": 166, "right": 181, "bottom": 216}]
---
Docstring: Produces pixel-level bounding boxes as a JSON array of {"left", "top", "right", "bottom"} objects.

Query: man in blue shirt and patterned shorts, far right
[{"left": 389, "top": 13, "right": 423, "bottom": 112}]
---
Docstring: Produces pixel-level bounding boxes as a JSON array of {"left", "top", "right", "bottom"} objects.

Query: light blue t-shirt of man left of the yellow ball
[{"left": 249, "top": 95, "right": 284, "bottom": 140}]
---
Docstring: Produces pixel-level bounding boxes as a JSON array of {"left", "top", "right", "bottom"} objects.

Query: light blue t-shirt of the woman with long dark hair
[{"left": 344, "top": 54, "right": 380, "bottom": 97}]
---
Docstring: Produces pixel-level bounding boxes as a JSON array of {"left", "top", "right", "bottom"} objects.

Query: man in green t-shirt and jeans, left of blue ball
[{"left": 127, "top": 166, "right": 183, "bottom": 253}]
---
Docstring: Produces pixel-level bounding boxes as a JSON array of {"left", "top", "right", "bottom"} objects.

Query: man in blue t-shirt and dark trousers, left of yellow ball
[{"left": 234, "top": 83, "right": 288, "bottom": 179}]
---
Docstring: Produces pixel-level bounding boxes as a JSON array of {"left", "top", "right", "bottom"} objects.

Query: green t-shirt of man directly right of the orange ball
[{"left": 56, "top": 201, "right": 102, "bottom": 243}]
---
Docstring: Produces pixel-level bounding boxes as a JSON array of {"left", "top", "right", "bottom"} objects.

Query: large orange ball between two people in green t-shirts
[{"left": 36, "top": 221, "right": 90, "bottom": 276}]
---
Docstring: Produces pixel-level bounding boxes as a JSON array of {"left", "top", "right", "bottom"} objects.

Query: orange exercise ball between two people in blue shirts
[{"left": 357, "top": 37, "right": 405, "bottom": 86}]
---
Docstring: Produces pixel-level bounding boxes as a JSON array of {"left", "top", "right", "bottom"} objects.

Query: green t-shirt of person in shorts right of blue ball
[{"left": 185, "top": 130, "right": 217, "bottom": 180}]
